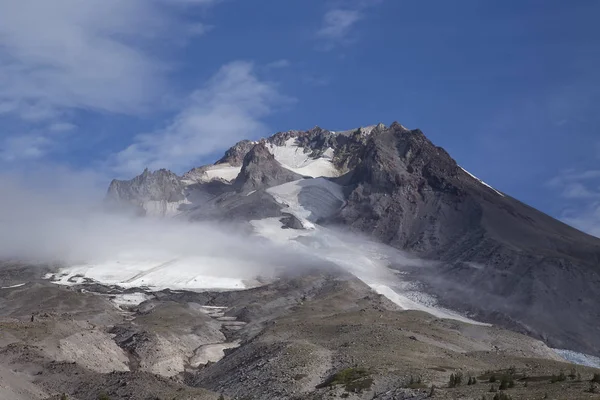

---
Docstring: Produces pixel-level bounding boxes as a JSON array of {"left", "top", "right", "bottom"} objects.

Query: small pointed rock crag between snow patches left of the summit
[{"left": 234, "top": 142, "right": 302, "bottom": 192}]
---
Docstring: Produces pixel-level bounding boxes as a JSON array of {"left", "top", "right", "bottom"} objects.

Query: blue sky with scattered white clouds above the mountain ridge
[{"left": 0, "top": 0, "right": 600, "bottom": 235}]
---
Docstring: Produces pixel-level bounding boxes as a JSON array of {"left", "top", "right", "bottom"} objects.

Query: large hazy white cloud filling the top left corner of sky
[{"left": 0, "top": 0, "right": 216, "bottom": 120}]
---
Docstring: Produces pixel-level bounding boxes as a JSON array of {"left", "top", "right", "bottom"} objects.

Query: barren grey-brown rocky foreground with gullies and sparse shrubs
[{"left": 0, "top": 265, "right": 600, "bottom": 400}]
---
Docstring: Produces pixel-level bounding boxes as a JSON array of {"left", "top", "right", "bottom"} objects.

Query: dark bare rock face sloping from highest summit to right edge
[{"left": 332, "top": 123, "right": 600, "bottom": 354}]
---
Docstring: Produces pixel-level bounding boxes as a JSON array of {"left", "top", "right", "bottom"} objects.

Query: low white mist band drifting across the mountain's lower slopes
[{"left": 0, "top": 166, "right": 432, "bottom": 290}]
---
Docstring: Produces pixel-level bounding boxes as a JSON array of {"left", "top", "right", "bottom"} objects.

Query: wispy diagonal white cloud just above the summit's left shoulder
[{"left": 111, "top": 61, "right": 291, "bottom": 175}]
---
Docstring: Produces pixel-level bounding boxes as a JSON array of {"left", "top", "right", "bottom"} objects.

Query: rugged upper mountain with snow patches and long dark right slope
[{"left": 107, "top": 123, "right": 600, "bottom": 355}]
